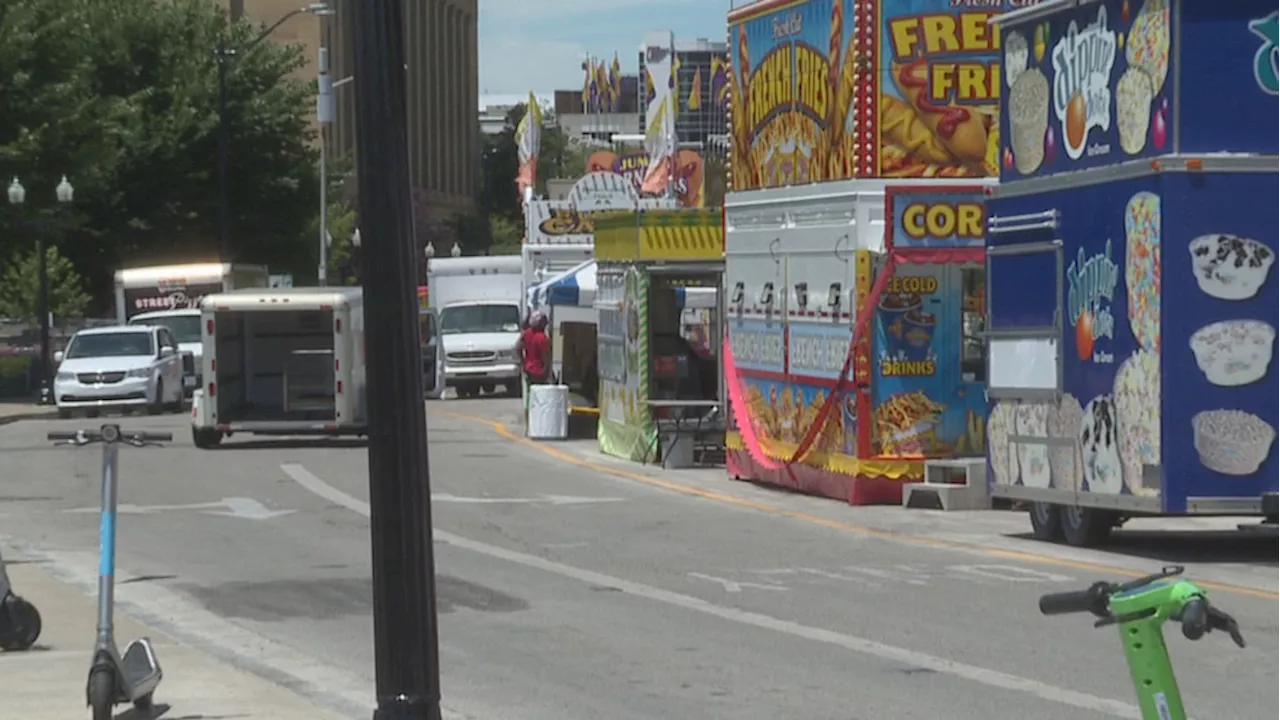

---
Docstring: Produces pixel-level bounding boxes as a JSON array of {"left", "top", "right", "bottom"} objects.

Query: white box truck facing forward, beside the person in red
[{"left": 428, "top": 255, "right": 524, "bottom": 397}]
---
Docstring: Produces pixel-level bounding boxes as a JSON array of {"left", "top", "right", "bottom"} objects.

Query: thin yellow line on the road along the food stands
[{"left": 433, "top": 410, "right": 1280, "bottom": 600}]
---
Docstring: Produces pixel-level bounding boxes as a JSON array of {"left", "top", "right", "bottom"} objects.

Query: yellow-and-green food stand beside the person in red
[{"left": 595, "top": 209, "right": 724, "bottom": 466}]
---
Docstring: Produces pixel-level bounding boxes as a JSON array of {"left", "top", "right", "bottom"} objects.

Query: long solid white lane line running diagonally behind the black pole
[{"left": 280, "top": 464, "right": 1142, "bottom": 720}]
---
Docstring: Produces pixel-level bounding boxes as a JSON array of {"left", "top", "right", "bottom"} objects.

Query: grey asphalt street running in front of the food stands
[{"left": 0, "top": 400, "right": 1280, "bottom": 720}]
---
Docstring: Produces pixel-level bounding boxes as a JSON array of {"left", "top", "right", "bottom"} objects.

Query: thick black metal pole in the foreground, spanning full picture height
[{"left": 352, "top": 0, "right": 440, "bottom": 720}]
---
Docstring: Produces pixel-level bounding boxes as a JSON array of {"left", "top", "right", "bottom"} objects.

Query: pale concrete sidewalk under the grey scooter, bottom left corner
[{"left": 0, "top": 565, "right": 338, "bottom": 720}]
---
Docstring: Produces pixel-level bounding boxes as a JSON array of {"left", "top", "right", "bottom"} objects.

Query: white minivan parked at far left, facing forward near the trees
[{"left": 54, "top": 325, "right": 183, "bottom": 418}]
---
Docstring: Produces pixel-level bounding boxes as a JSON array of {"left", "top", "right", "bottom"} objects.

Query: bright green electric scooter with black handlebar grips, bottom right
[{"left": 1041, "top": 566, "right": 1244, "bottom": 720}]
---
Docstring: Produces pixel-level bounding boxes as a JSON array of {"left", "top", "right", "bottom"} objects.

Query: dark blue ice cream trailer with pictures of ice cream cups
[{"left": 987, "top": 0, "right": 1280, "bottom": 546}]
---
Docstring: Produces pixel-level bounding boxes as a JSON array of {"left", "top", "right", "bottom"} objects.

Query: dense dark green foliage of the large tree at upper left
[{"left": 0, "top": 0, "right": 319, "bottom": 302}]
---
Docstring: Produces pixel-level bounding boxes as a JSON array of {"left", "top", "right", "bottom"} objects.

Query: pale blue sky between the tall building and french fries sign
[{"left": 479, "top": 0, "right": 745, "bottom": 95}]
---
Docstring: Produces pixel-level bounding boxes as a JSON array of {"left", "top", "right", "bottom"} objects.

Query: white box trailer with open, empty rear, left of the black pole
[{"left": 191, "top": 287, "right": 367, "bottom": 448}]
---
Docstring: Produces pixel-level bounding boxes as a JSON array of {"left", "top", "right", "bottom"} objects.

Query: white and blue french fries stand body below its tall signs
[{"left": 726, "top": 181, "right": 984, "bottom": 505}]
